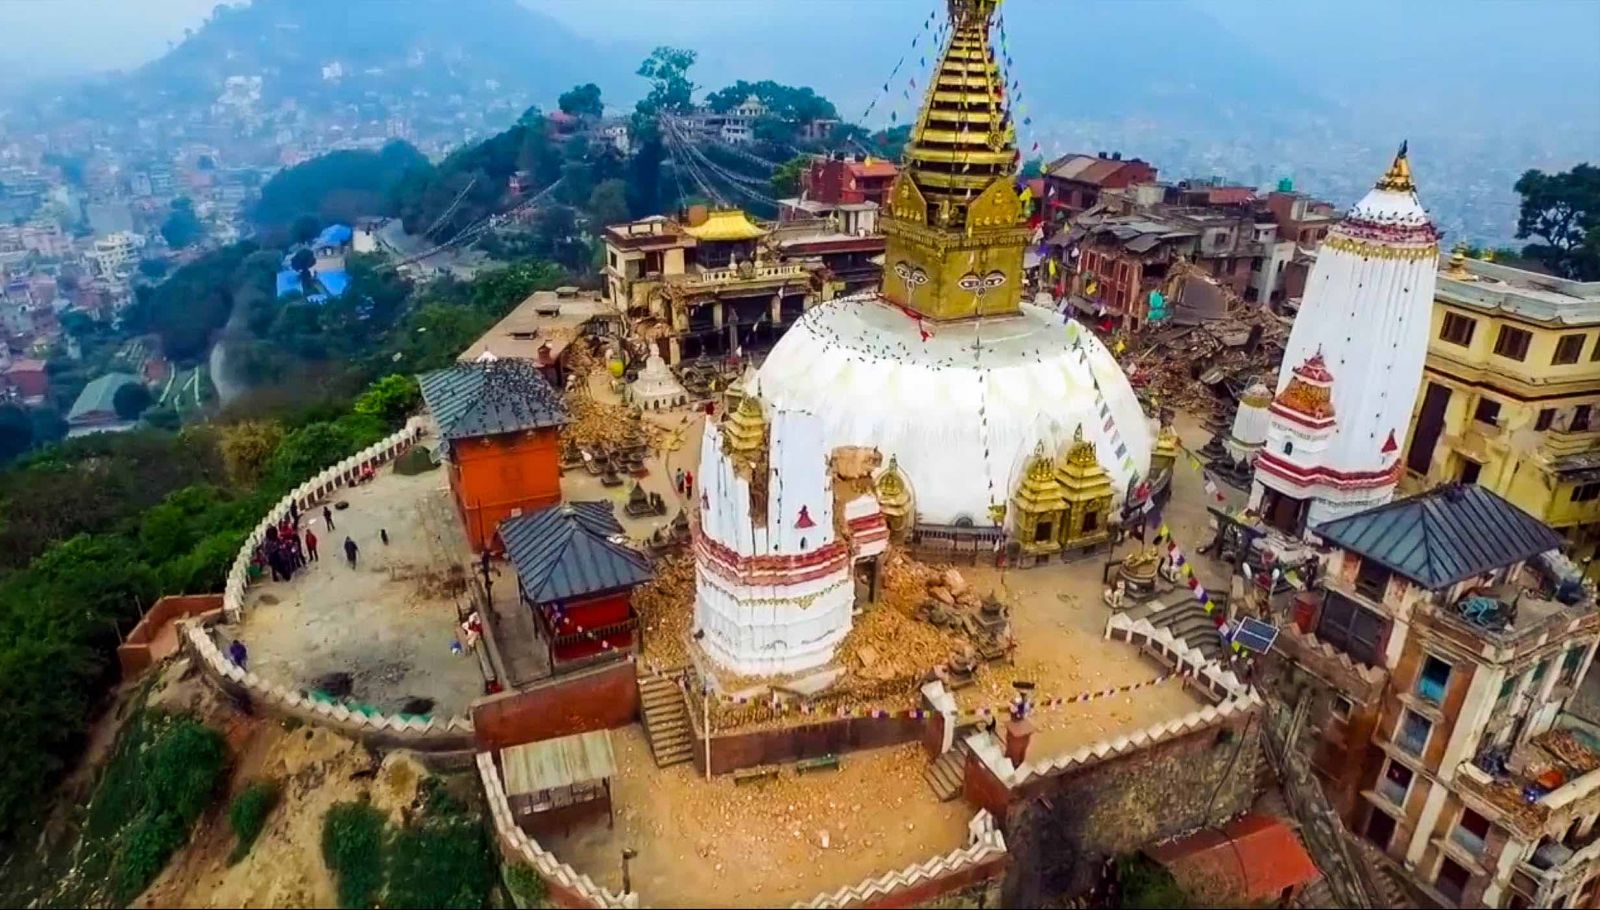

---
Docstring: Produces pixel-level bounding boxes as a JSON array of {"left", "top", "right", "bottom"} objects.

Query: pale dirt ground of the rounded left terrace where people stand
[{"left": 230, "top": 454, "right": 483, "bottom": 716}]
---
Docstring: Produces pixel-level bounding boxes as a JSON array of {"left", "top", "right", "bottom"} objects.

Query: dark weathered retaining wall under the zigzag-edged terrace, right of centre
[{"left": 998, "top": 712, "right": 1261, "bottom": 907}]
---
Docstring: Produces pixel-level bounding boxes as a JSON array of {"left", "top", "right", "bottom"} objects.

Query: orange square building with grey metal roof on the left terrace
[{"left": 418, "top": 358, "right": 566, "bottom": 550}]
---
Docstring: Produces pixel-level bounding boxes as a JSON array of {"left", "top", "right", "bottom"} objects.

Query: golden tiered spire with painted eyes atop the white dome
[{"left": 883, "top": 0, "right": 1029, "bottom": 320}]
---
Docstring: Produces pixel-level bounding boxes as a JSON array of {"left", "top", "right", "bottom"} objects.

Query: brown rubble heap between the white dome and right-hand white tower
[{"left": 1122, "top": 305, "right": 1290, "bottom": 416}]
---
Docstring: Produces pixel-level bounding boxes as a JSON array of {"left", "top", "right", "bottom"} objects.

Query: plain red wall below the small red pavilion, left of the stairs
[{"left": 472, "top": 661, "right": 638, "bottom": 748}]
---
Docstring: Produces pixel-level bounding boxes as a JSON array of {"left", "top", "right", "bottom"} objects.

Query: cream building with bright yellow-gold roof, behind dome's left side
[{"left": 602, "top": 210, "right": 832, "bottom": 365}]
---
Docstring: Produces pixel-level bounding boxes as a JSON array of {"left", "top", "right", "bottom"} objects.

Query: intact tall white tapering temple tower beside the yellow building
[{"left": 1250, "top": 146, "right": 1438, "bottom": 534}]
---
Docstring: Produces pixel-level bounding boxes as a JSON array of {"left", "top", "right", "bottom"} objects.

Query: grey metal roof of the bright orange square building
[{"left": 418, "top": 358, "right": 568, "bottom": 440}]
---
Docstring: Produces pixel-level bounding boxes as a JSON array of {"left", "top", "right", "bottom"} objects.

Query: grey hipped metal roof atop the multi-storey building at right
[{"left": 1314, "top": 483, "right": 1562, "bottom": 590}]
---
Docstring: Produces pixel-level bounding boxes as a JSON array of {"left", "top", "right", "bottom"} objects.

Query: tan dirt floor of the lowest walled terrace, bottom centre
[{"left": 539, "top": 726, "right": 974, "bottom": 907}]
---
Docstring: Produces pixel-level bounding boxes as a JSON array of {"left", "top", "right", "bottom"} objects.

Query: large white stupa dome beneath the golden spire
[{"left": 758, "top": 294, "right": 1150, "bottom": 526}]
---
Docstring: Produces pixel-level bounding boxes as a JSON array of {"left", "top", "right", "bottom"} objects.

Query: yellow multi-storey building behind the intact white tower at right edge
[{"left": 1405, "top": 254, "right": 1600, "bottom": 577}]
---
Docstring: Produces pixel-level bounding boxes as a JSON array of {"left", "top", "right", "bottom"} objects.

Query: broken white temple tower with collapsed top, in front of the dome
[{"left": 694, "top": 395, "right": 888, "bottom": 675}]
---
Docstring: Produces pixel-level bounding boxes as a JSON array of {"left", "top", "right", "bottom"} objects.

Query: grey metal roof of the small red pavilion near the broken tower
[{"left": 499, "top": 502, "right": 651, "bottom": 603}]
